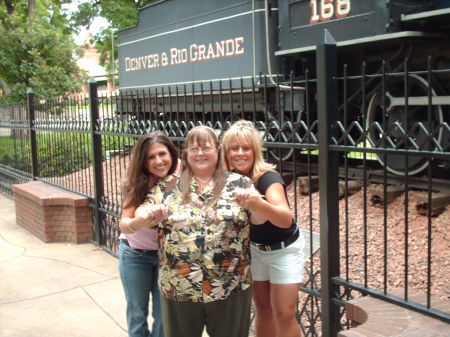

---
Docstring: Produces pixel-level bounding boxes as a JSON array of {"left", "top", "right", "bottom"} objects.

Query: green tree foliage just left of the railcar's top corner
[{"left": 72, "top": 0, "right": 152, "bottom": 86}]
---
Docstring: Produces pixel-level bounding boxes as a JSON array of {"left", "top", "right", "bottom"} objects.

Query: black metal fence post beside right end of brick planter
[{"left": 89, "top": 78, "right": 104, "bottom": 246}]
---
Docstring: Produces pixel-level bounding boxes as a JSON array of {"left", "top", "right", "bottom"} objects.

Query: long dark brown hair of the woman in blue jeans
[{"left": 122, "top": 131, "right": 178, "bottom": 208}]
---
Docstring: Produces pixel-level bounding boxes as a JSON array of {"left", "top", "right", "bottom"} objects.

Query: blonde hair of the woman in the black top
[{"left": 222, "top": 120, "right": 275, "bottom": 185}]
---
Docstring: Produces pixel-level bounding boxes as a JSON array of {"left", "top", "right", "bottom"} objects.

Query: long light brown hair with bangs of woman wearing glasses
[{"left": 180, "top": 125, "right": 226, "bottom": 207}]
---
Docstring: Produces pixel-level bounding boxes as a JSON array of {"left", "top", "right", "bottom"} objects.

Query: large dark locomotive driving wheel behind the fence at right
[{"left": 366, "top": 75, "right": 444, "bottom": 175}]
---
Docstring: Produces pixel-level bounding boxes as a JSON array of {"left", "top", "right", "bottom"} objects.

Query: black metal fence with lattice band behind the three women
[{"left": 0, "top": 38, "right": 450, "bottom": 336}]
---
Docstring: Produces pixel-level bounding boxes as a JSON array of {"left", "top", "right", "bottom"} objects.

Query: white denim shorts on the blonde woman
[{"left": 250, "top": 231, "right": 305, "bottom": 284}]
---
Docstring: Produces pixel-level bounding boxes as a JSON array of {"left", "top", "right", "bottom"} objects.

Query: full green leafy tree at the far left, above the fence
[{"left": 0, "top": 0, "right": 86, "bottom": 101}]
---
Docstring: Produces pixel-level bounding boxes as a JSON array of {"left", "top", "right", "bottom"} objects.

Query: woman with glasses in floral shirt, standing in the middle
[{"left": 141, "top": 126, "right": 257, "bottom": 337}]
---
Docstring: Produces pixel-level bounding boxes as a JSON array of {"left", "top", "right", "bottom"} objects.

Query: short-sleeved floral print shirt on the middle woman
[{"left": 148, "top": 171, "right": 252, "bottom": 303}]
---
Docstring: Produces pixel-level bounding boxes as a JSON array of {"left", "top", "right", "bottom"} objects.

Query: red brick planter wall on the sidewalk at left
[{"left": 13, "top": 181, "right": 93, "bottom": 243}]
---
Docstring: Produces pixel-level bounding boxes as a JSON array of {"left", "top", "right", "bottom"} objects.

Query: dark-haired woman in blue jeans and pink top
[{"left": 119, "top": 131, "right": 178, "bottom": 337}]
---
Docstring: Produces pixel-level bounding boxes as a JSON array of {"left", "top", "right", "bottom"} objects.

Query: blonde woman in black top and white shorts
[{"left": 222, "top": 120, "right": 304, "bottom": 337}]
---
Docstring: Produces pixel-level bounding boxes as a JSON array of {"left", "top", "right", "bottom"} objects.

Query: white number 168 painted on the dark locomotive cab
[{"left": 309, "top": 0, "right": 351, "bottom": 24}]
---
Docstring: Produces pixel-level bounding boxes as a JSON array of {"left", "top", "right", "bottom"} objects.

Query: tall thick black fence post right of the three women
[{"left": 316, "top": 29, "right": 340, "bottom": 337}]
